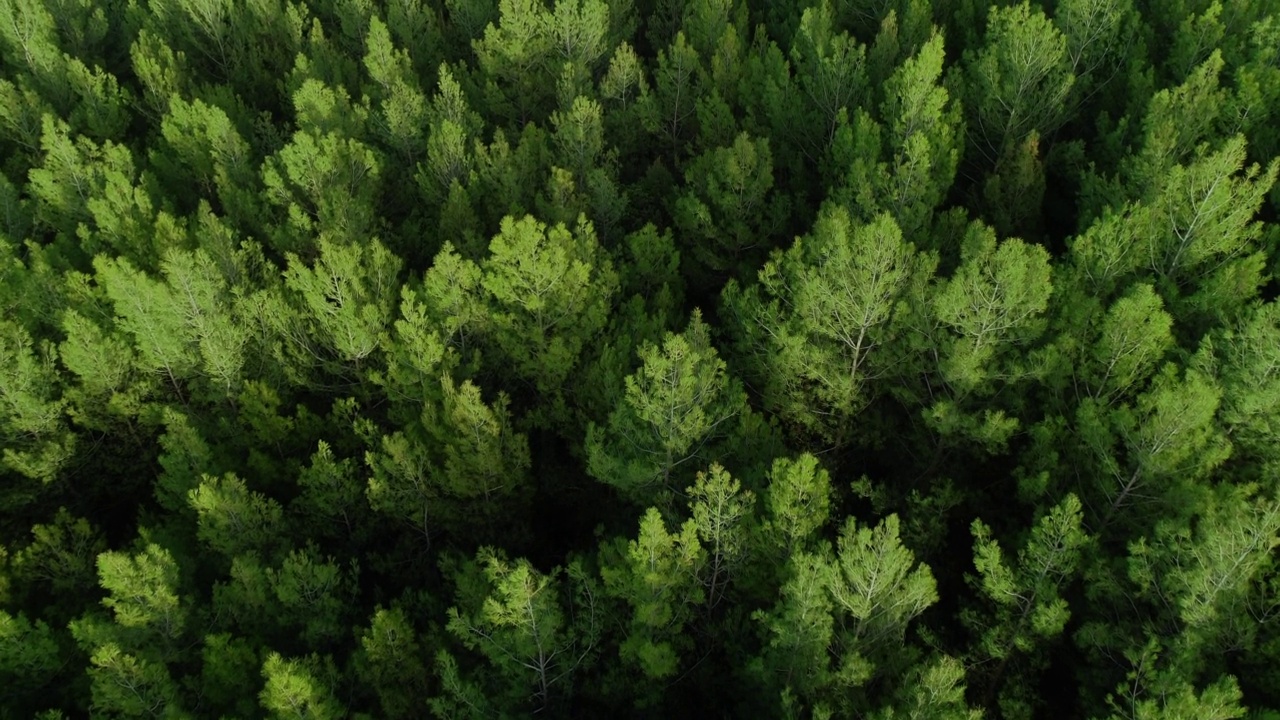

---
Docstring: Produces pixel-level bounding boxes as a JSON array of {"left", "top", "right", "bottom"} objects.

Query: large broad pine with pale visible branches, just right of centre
[{"left": 724, "top": 209, "right": 931, "bottom": 442}]
